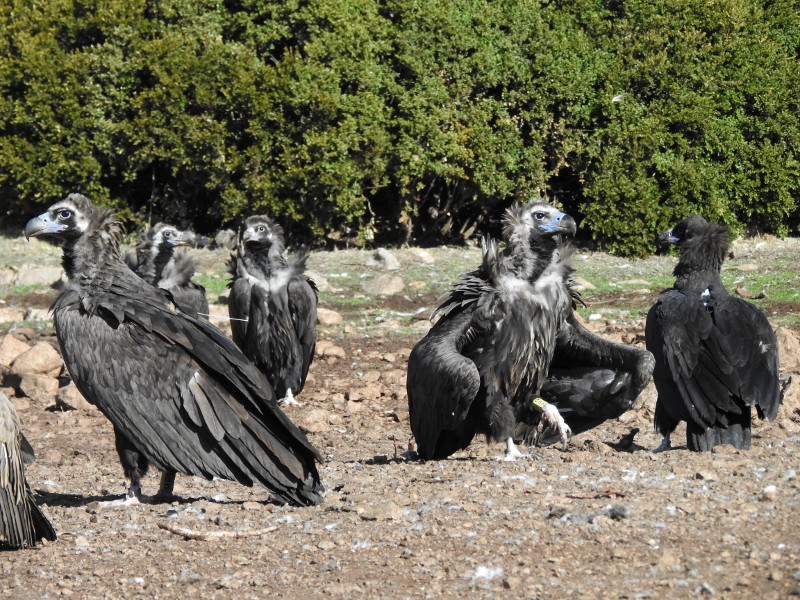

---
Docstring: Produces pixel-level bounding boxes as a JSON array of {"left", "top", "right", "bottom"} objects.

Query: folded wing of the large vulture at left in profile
[{"left": 53, "top": 282, "right": 322, "bottom": 504}]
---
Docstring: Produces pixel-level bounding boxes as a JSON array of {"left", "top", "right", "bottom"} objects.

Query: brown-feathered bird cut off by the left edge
[{"left": 0, "top": 391, "right": 56, "bottom": 549}]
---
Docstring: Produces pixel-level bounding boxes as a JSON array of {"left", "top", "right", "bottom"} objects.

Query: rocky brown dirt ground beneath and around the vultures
[{"left": 0, "top": 233, "right": 800, "bottom": 600}]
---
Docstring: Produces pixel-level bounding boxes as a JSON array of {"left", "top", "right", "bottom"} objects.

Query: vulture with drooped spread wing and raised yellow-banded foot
[{"left": 407, "top": 201, "right": 653, "bottom": 460}]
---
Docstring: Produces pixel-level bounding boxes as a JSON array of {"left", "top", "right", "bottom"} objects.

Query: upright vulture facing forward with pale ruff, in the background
[{"left": 228, "top": 215, "right": 317, "bottom": 404}]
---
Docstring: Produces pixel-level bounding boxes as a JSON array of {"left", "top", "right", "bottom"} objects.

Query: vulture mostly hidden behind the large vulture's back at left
[{"left": 125, "top": 223, "right": 208, "bottom": 317}]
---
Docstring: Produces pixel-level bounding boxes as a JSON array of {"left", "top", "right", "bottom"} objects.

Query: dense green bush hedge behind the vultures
[{"left": 0, "top": 0, "right": 800, "bottom": 254}]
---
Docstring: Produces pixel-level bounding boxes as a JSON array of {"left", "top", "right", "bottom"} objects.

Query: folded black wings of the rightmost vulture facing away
[{"left": 645, "top": 290, "right": 780, "bottom": 427}]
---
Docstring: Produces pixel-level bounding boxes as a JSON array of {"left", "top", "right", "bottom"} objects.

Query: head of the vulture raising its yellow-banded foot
[{"left": 503, "top": 200, "right": 577, "bottom": 248}]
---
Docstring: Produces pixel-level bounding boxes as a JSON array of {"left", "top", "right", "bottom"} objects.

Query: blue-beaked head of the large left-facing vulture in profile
[{"left": 25, "top": 194, "right": 116, "bottom": 244}]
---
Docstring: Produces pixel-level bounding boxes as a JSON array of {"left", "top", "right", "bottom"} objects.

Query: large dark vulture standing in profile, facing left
[{"left": 25, "top": 194, "right": 323, "bottom": 505}]
